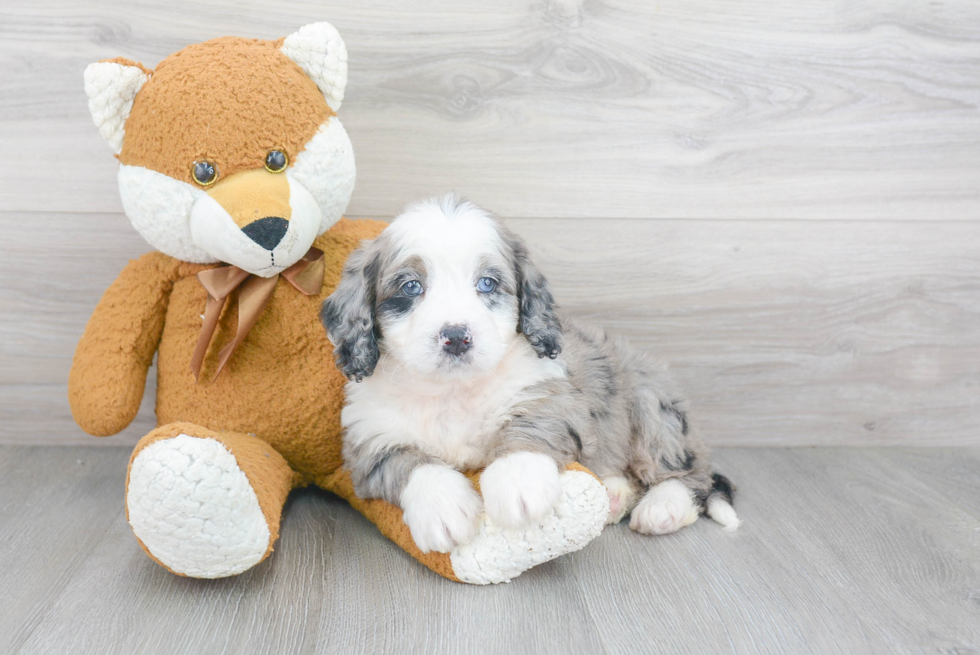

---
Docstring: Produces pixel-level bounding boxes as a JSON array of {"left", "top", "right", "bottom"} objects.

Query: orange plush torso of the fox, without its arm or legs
[{"left": 157, "top": 219, "right": 384, "bottom": 484}]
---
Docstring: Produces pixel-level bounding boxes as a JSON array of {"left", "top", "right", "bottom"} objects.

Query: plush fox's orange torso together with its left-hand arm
[{"left": 69, "top": 219, "right": 385, "bottom": 484}]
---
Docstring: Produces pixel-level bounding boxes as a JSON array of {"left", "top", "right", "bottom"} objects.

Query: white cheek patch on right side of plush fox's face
[{"left": 286, "top": 116, "right": 357, "bottom": 234}]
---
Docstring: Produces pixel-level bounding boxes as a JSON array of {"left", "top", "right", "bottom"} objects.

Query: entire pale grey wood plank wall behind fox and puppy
[{"left": 0, "top": 0, "right": 980, "bottom": 445}]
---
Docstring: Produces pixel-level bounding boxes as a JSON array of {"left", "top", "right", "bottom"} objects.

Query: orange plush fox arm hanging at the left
[{"left": 68, "top": 252, "right": 179, "bottom": 437}]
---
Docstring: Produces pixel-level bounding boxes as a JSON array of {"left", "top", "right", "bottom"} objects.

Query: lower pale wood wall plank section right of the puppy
[{"left": 512, "top": 220, "right": 980, "bottom": 445}]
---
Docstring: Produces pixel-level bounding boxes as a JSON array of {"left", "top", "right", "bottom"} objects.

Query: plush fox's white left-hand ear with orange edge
[{"left": 85, "top": 59, "right": 150, "bottom": 155}]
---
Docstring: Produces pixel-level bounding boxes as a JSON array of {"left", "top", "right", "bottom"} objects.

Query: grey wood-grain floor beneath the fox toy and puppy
[{"left": 0, "top": 446, "right": 980, "bottom": 655}]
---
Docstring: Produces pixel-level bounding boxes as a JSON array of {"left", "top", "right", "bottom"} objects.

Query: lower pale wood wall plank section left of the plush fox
[{"left": 0, "top": 212, "right": 156, "bottom": 445}]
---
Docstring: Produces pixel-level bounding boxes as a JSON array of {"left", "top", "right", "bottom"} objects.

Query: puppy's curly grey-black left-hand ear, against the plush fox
[{"left": 320, "top": 242, "right": 381, "bottom": 382}]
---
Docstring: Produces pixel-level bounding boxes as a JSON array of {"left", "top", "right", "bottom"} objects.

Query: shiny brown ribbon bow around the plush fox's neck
[{"left": 191, "top": 248, "right": 324, "bottom": 380}]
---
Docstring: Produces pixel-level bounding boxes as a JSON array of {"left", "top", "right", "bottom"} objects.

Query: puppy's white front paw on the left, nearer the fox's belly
[{"left": 401, "top": 464, "right": 483, "bottom": 553}]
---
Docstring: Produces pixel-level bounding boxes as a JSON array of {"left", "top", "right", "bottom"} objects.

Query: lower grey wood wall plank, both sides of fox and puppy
[{"left": 0, "top": 214, "right": 980, "bottom": 445}]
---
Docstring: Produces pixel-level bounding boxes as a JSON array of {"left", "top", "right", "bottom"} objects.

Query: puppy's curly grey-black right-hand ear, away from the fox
[{"left": 507, "top": 233, "right": 563, "bottom": 359}]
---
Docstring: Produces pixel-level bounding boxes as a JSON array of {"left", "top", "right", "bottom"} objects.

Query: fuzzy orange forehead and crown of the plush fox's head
[{"left": 119, "top": 37, "right": 333, "bottom": 184}]
